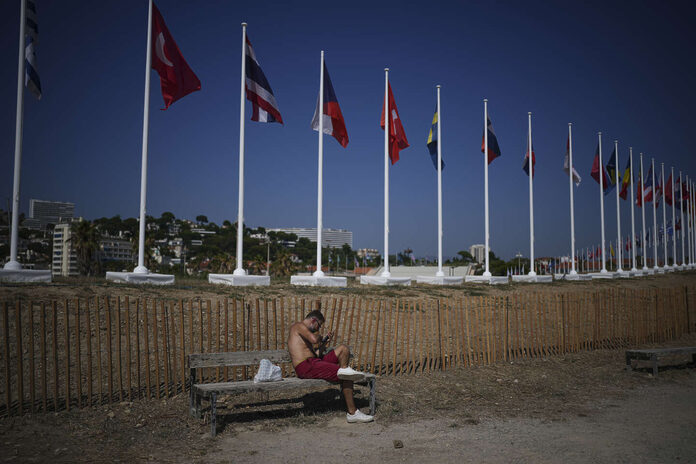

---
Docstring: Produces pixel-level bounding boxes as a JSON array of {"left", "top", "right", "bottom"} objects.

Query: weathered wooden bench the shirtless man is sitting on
[{"left": 188, "top": 350, "right": 377, "bottom": 436}]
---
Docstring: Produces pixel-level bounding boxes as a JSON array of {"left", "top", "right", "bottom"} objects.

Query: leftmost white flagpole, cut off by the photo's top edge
[{"left": 3, "top": 0, "right": 27, "bottom": 271}]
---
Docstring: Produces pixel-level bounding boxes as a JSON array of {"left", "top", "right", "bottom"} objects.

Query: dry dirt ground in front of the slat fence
[{"left": 0, "top": 333, "right": 696, "bottom": 463}]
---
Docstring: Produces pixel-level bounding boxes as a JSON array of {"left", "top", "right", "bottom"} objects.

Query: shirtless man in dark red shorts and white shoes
[{"left": 288, "top": 309, "right": 374, "bottom": 423}]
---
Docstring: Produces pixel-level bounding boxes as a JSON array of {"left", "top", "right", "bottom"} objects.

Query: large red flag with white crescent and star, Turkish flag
[{"left": 152, "top": 3, "right": 201, "bottom": 110}]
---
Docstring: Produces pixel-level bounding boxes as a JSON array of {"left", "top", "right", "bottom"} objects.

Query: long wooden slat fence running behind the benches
[{"left": 0, "top": 286, "right": 696, "bottom": 416}]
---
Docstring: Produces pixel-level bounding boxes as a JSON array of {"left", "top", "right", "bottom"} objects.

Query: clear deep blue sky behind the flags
[{"left": 0, "top": 0, "right": 696, "bottom": 258}]
